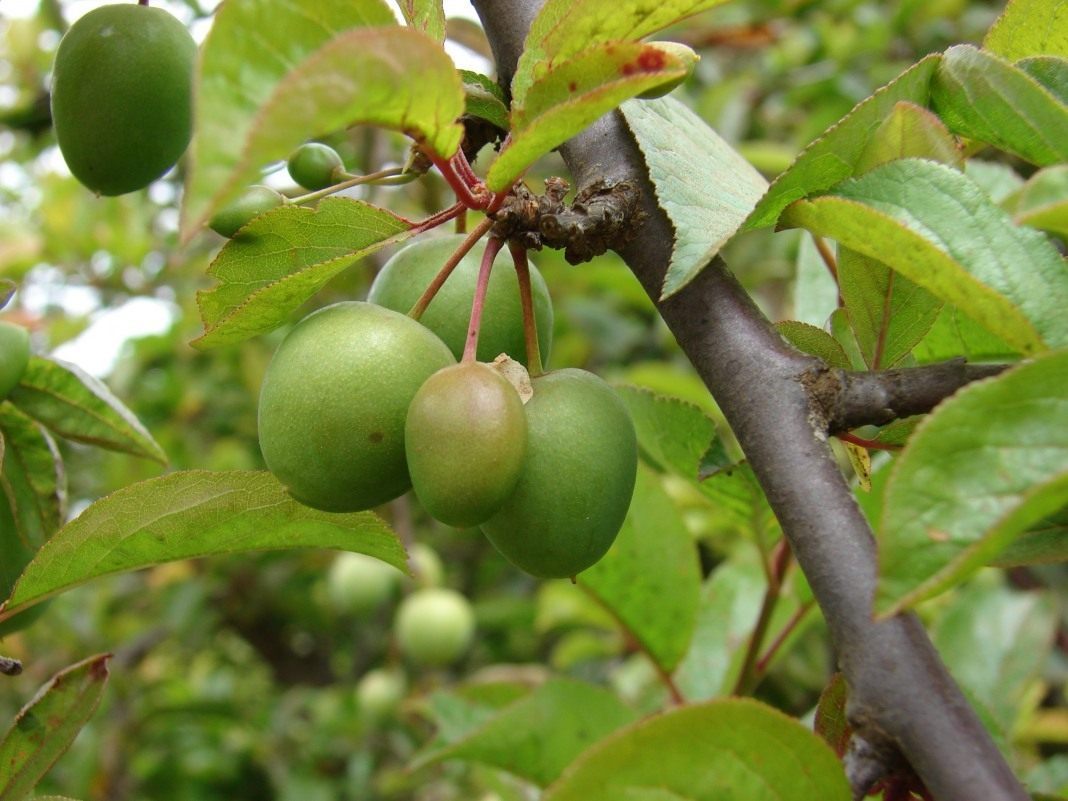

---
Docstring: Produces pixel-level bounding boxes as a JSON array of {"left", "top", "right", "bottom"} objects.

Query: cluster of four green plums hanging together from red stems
[{"left": 258, "top": 235, "right": 638, "bottom": 578}]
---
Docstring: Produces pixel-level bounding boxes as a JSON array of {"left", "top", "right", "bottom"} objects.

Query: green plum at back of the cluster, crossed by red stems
[{"left": 367, "top": 234, "right": 552, "bottom": 364}]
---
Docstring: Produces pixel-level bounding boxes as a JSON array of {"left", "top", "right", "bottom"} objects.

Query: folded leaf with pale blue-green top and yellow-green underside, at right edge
[{"left": 783, "top": 159, "right": 1068, "bottom": 352}]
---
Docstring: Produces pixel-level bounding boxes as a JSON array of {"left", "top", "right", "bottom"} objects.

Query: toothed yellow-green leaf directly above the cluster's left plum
[{"left": 193, "top": 198, "right": 412, "bottom": 348}]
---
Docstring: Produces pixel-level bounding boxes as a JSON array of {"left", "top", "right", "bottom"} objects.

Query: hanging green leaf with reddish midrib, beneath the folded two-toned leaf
[{"left": 838, "top": 248, "right": 943, "bottom": 370}]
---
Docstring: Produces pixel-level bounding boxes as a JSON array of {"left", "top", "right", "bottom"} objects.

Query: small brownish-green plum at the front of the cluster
[{"left": 405, "top": 362, "right": 527, "bottom": 528}]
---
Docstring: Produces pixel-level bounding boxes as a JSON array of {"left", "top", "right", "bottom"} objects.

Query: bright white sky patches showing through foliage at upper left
[{"left": 3, "top": 0, "right": 486, "bottom": 378}]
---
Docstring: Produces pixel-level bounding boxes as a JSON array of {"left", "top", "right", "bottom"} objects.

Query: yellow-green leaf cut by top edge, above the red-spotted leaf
[{"left": 512, "top": 0, "right": 725, "bottom": 105}]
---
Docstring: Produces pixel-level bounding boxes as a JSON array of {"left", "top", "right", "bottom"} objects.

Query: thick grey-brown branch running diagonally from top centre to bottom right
[{"left": 474, "top": 0, "right": 1027, "bottom": 801}]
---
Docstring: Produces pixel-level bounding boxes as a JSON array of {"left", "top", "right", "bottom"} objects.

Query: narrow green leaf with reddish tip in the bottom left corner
[{"left": 0, "top": 654, "right": 111, "bottom": 801}]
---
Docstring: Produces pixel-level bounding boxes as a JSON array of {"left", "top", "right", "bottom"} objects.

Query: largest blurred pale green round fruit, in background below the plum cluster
[{"left": 393, "top": 588, "right": 474, "bottom": 668}]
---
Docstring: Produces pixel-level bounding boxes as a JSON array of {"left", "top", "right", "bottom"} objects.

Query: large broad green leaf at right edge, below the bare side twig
[{"left": 876, "top": 350, "right": 1068, "bottom": 615}]
